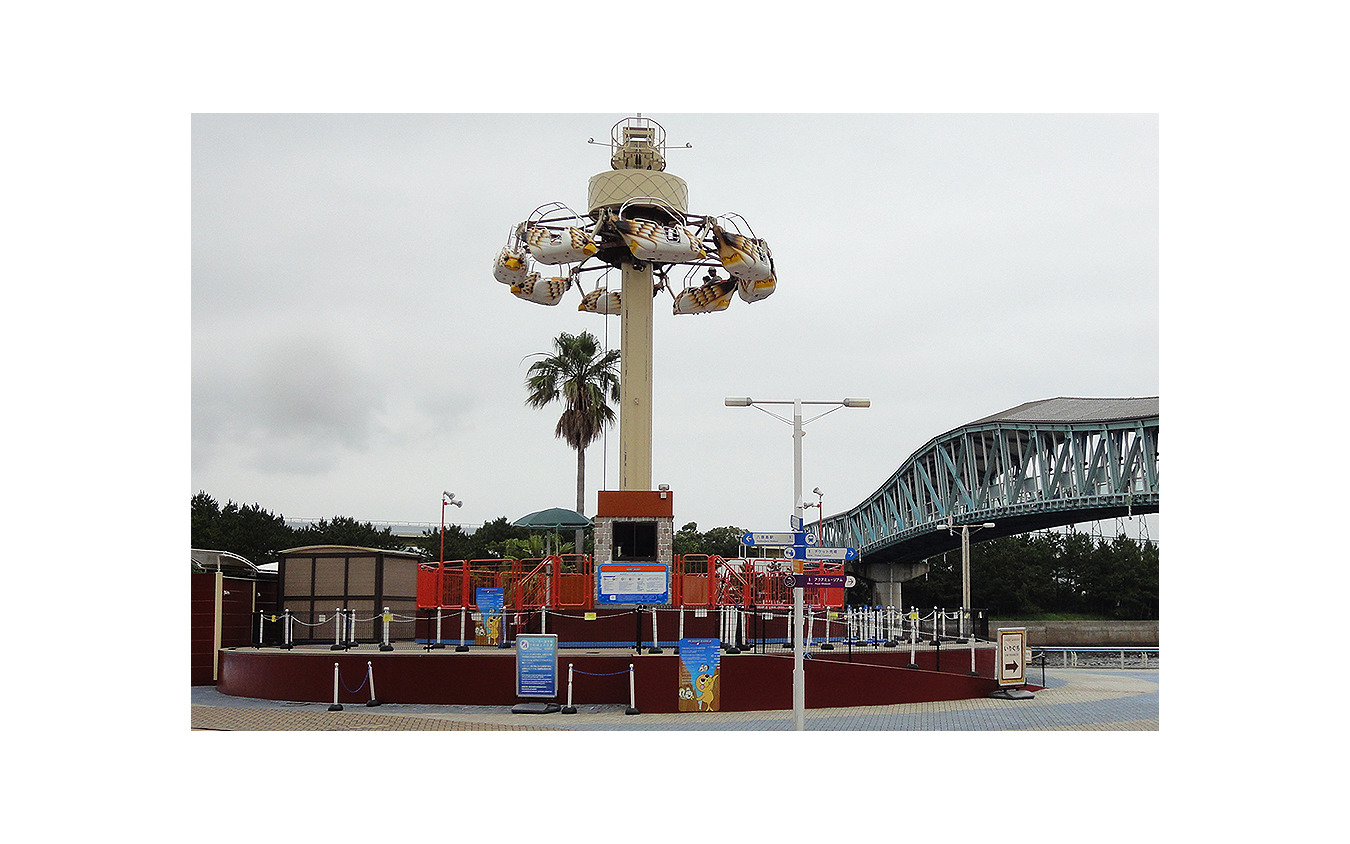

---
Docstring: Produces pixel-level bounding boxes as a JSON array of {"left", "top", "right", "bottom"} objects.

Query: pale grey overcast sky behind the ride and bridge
[{"left": 192, "top": 113, "right": 1158, "bottom": 529}]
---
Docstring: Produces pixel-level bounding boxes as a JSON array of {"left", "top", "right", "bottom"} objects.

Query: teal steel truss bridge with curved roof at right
[{"left": 821, "top": 396, "right": 1158, "bottom": 569}]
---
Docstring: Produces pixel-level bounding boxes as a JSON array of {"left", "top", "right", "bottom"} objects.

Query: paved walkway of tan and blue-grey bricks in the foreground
[{"left": 192, "top": 668, "right": 1158, "bottom": 731}]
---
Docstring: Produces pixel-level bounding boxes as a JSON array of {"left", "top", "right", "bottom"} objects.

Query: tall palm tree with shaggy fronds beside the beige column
[{"left": 525, "top": 331, "right": 620, "bottom": 552}]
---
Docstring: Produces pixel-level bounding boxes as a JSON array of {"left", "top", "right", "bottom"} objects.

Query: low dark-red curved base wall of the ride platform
[{"left": 217, "top": 644, "right": 1035, "bottom": 713}]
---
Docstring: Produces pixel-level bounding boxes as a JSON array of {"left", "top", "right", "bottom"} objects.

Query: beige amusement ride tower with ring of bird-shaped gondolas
[{"left": 493, "top": 115, "right": 776, "bottom": 490}]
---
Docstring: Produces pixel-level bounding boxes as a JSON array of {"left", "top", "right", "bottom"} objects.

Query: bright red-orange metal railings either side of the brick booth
[{"left": 417, "top": 554, "right": 846, "bottom": 612}]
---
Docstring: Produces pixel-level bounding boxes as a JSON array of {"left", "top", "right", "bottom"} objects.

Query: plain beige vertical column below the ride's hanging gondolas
[{"left": 618, "top": 261, "right": 653, "bottom": 490}]
